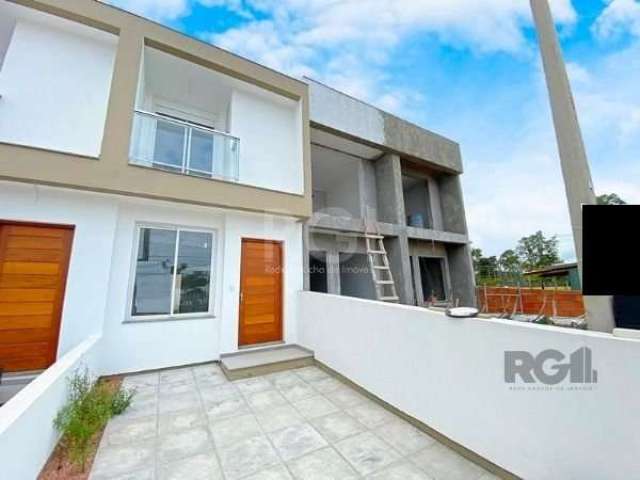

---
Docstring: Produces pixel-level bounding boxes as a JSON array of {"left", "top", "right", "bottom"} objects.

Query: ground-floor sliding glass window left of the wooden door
[{"left": 131, "top": 227, "right": 214, "bottom": 318}]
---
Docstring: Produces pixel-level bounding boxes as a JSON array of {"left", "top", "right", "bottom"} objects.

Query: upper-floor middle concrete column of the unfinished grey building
[{"left": 374, "top": 154, "right": 406, "bottom": 225}]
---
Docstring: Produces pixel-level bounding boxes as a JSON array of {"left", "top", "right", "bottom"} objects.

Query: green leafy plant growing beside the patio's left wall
[{"left": 53, "top": 369, "right": 135, "bottom": 472}]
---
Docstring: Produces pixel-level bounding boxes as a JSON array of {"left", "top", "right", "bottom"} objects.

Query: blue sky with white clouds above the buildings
[{"left": 110, "top": 0, "right": 640, "bottom": 260}]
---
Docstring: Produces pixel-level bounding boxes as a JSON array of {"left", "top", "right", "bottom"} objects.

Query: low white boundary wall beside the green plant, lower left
[{"left": 0, "top": 335, "right": 100, "bottom": 480}]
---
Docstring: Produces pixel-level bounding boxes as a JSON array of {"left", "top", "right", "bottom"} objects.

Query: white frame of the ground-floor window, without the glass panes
[{"left": 124, "top": 222, "right": 218, "bottom": 323}]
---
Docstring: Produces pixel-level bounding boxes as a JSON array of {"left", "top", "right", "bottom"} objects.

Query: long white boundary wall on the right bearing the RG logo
[{"left": 298, "top": 292, "right": 640, "bottom": 480}]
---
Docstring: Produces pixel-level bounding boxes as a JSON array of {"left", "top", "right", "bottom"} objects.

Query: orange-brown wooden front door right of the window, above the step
[{"left": 238, "top": 239, "right": 282, "bottom": 345}]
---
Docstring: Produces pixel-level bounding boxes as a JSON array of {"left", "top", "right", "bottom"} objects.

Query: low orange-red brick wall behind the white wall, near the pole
[{"left": 476, "top": 287, "right": 584, "bottom": 317}]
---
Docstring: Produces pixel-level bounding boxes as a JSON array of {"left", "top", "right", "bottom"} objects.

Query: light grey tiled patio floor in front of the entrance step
[{"left": 91, "top": 364, "right": 495, "bottom": 480}]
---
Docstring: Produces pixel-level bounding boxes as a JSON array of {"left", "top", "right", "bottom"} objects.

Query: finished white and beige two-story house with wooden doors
[{"left": 0, "top": 0, "right": 311, "bottom": 378}]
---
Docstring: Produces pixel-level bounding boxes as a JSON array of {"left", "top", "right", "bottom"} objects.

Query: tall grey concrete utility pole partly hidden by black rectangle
[{"left": 530, "top": 0, "right": 615, "bottom": 332}]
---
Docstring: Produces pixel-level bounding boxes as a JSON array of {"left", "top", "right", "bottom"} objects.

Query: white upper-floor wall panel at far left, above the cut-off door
[{"left": 0, "top": 10, "right": 117, "bottom": 157}]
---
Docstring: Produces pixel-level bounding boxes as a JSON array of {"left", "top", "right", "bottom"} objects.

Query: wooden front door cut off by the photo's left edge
[{"left": 0, "top": 222, "right": 73, "bottom": 372}]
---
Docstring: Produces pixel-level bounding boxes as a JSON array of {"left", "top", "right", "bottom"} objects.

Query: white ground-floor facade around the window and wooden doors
[{"left": 0, "top": 182, "right": 302, "bottom": 374}]
